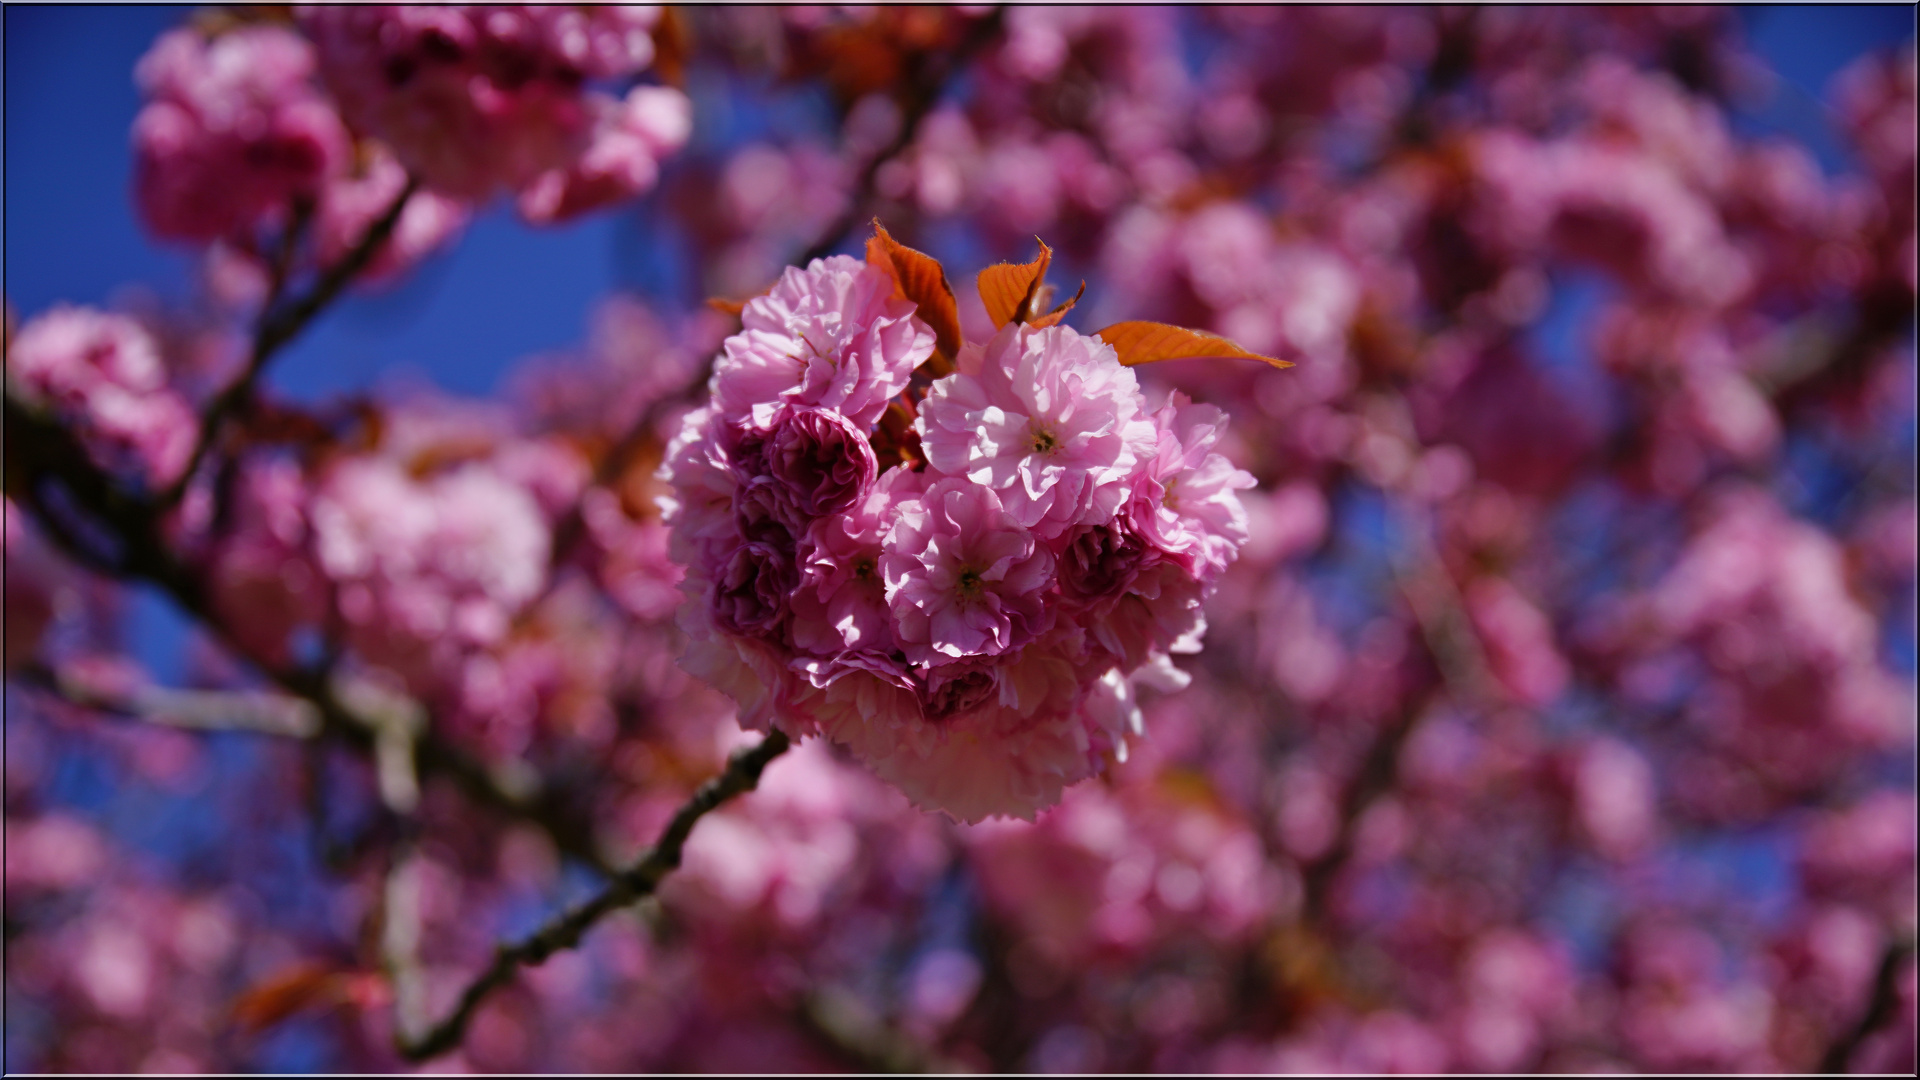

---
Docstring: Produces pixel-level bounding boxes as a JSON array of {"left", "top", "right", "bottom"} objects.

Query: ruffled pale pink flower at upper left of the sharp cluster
[{"left": 712, "top": 256, "right": 933, "bottom": 429}]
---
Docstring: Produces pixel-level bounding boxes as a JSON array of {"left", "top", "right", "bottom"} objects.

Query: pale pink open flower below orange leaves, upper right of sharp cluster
[{"left": 918, "top": 323, "right": 1152, "bottom": 540}]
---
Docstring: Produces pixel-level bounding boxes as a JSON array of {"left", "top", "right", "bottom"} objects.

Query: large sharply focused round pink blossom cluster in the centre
[{"left": 662, "top": 247, "right": 1254, "bottom": 821}]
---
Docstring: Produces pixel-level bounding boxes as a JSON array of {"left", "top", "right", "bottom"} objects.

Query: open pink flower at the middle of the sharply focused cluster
[{"left": 879, "top": 480, "right": 1054, "bottom": 663}]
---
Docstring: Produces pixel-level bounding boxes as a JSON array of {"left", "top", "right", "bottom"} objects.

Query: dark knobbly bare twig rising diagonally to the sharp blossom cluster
[{"left": 396, "top": 730, "right": 791, "bottom": 1061}]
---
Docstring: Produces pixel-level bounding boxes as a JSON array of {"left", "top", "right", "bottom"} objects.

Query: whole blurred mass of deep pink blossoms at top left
[{"left": 132, "top": 6, "right": 691, "bottom": 271}]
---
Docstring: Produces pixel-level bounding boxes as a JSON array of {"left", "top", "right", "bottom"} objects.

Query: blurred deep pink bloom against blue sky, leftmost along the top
[{"left": 132, "top": 27, "right": 349, "bottom": 240}]
